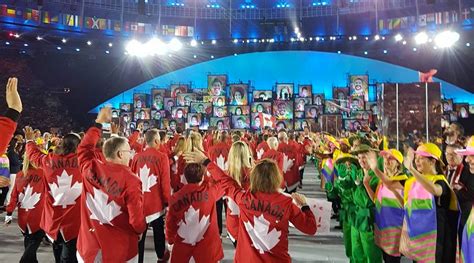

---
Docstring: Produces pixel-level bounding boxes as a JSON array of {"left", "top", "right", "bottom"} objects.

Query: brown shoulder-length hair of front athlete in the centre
[{"left": 250, "top": 159, "right": 283, "bottom": 193}]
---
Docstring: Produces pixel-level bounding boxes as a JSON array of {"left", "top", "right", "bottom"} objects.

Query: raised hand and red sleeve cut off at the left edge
[{"left": 0, "top": 78, "right": 23, "bottom": 154}]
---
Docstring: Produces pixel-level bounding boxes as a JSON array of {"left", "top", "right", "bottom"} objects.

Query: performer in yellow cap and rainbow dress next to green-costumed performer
[{"left": 366, "top": 149, "right": 408, "bottom": 263}]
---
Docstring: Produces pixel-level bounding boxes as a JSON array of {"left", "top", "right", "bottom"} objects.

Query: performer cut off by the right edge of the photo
[{"left": 456, "top": 136, "right": 474, "bottom": 263}]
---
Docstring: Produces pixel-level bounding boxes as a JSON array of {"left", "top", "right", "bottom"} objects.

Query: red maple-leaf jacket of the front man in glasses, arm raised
[{"left": 77, "top": 127, "right": 146, "bottom": 262}]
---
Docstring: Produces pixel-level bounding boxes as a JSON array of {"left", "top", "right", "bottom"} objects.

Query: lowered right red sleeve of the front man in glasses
[{"left": 125, "top": 178, "right": 146, "bottom": 235}]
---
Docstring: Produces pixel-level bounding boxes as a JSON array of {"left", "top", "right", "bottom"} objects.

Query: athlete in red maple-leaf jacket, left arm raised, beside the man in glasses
[{"left": 25, "top": 127, "right": 82, "bottom": 262}]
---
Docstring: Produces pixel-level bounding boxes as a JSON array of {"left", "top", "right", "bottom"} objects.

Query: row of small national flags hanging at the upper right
[{"left": 378, "top": 7, "right": 474, "bottom": 31}]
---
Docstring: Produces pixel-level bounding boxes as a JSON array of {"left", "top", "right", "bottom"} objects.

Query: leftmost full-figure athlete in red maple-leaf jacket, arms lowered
[{"left": 5, "top": 162, "right": 47, "bottom": 262}]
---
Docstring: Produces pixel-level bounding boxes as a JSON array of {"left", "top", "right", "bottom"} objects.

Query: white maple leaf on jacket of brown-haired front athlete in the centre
[{"left": 244, "top": 215, "right": 281, "bottom": 254}]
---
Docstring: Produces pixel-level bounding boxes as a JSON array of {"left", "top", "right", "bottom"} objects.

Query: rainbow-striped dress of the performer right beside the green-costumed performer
[{"left": 374, "top": 174, "right": 408, "bottom": 257}]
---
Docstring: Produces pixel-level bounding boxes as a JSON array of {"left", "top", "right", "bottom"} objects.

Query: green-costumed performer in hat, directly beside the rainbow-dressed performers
[{"left": 351, "top": 144, "right": 382, "bottom": 263}]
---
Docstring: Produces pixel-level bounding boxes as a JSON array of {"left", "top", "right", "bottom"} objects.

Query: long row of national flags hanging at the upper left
[{"left": 0, "top": 4, "right": 194, "bottom": 37}]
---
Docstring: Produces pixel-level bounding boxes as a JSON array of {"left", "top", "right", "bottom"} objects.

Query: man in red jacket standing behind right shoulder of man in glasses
[{"left": 132, "top": 129, "right": 171, "bottom": 263}]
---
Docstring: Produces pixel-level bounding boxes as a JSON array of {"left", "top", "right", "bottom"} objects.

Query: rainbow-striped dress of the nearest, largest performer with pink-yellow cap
[{"left": 400, "top": 175, "right": 458, "bottom": 263}]
